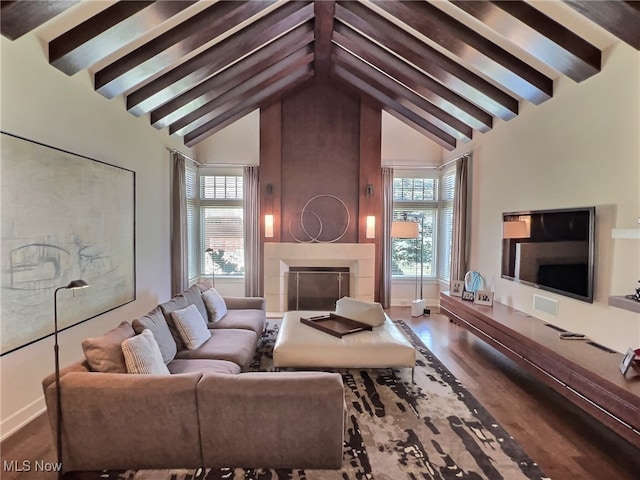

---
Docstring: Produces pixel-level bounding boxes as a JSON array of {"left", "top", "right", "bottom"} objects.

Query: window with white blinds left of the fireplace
[{"left": 187, "top": 167, "right": 244, "bottom": 281}]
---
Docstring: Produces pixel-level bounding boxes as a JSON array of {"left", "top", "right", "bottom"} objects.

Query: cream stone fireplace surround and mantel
[{"left": 264, "top": 243, "right": 375, "bottom": 314}]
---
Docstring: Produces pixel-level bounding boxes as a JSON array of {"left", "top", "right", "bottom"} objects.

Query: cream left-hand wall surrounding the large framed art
[{"left": 0, "top": 34, "right": 192, "bottom": 437}]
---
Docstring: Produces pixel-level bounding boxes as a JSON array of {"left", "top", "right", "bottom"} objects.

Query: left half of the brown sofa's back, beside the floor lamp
[{"left": 45, "top": 371, "right": 202, "bottom": 471}]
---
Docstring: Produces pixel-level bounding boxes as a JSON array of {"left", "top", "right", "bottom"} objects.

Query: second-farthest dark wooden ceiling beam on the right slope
[{"left": 331, "top": 46, "right": 473, "bottom": 142}]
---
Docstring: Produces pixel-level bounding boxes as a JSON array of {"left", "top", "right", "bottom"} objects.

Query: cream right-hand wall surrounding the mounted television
[{"left": 446, "top": 44, "right": 640, "bottom": 352}]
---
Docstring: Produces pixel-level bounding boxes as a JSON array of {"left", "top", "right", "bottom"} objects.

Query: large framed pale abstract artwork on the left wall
[{"left": 0, "top": 132, "right": 136, "bottom": 355}]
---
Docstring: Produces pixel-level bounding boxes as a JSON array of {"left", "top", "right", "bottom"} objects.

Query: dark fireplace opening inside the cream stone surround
[{"left": 287, "top": 267, "right": 349, "bottom": 310}]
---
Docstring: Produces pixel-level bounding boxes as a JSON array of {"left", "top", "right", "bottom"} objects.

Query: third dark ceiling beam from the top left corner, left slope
[{"left": 94, "top": 0, "right": 273, "bottom": 98}]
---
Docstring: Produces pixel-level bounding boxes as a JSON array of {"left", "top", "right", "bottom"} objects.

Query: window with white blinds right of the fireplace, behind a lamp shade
[{"left": 391, "top": 170, "right": 455, "bottom": 282}]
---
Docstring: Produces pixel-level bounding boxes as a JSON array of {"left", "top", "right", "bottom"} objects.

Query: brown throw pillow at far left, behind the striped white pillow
[{"left": 82, "top": 322, "right": 136, "bottom": 373}]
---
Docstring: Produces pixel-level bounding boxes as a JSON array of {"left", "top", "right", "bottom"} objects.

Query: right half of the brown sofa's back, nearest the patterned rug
[{"left": 197, "top": 372, "right": 345, "bottom": 469}]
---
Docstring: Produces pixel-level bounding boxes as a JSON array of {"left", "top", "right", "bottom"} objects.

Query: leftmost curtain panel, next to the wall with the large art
[{"left": 171, "top": 152, "right": 189, "bottom": 295}]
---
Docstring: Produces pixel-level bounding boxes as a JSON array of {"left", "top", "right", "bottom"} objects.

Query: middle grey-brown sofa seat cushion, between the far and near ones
[{"left": 176, "top": 329, "right": 258, "bottom": 371}]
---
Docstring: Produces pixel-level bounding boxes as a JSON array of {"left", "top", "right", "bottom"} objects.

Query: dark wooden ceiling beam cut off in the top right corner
[{"left": 564, "top": 0, "right": 640, "bottom": 50}]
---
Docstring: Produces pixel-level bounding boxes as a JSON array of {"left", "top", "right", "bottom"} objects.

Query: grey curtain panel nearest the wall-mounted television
[{"left": 451, "top": 155, "right": 469, "bottom": 280}]
